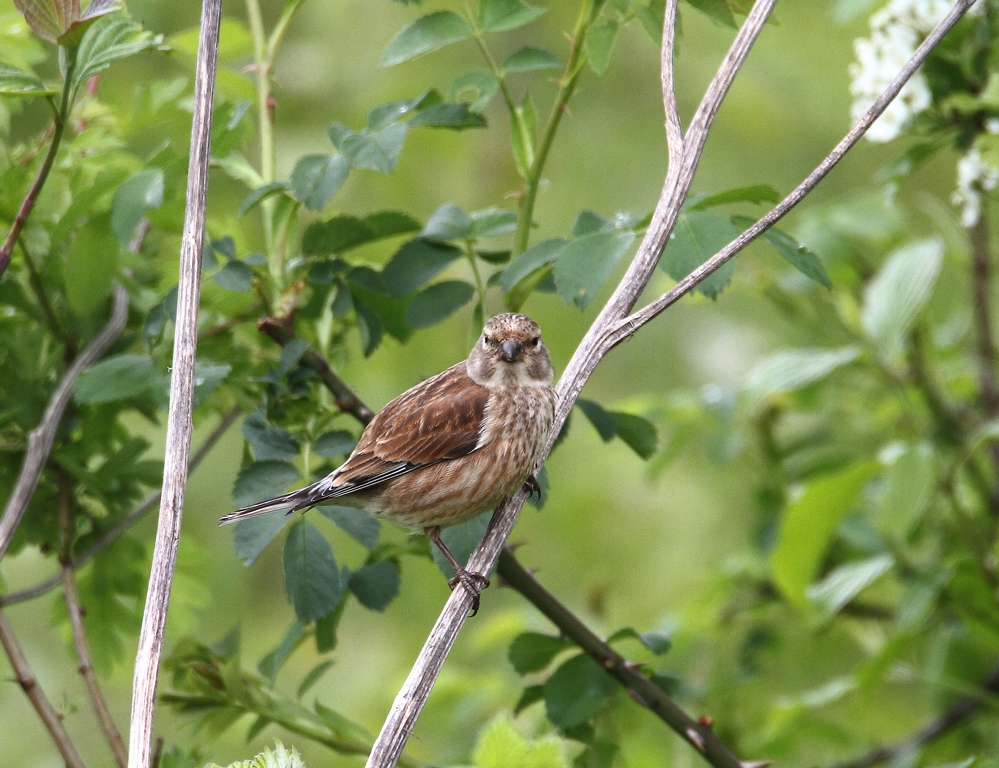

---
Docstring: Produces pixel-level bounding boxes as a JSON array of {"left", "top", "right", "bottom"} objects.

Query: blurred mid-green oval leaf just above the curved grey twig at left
[{"left": 64, "top": 214, "right": 118, "bottom": 317}]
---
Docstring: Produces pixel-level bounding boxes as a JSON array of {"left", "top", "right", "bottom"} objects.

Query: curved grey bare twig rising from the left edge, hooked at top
[{"left": 0, "top": 285, "right": 128, "bottom": 559}]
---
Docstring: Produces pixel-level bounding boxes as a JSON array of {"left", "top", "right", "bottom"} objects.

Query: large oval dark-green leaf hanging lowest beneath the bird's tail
[{"left": 282, "top": 519, "right": 343, "bottom": 624}]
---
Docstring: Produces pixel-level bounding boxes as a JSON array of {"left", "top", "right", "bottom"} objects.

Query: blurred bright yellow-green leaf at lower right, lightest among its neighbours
[{"left": 770, "top": 462, "right": 879, "bottom": 608}]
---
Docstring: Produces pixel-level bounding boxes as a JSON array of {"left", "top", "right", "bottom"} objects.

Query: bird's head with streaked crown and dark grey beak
[{"left": 468, "top": 312, "right": 554, "bottom": 386}]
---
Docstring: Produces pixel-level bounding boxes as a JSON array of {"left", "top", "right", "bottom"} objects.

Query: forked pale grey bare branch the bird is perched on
[{"left": 367, "top": 0, "right": 973, "bottom": 768}]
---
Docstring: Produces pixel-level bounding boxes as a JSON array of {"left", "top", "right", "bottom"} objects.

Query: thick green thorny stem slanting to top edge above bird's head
[{"left": 511, "top": 0, "right": 603, "bottom": 256}]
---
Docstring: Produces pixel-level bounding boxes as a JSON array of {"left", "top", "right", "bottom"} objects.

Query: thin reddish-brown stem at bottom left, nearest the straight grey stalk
[{"left": 59, "top": 469, "right": 128, "bottom": 768}]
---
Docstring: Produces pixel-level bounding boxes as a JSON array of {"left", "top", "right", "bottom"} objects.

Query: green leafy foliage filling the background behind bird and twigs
[{"left": 0, "top": 0, "right": 999, "bottom": 768}]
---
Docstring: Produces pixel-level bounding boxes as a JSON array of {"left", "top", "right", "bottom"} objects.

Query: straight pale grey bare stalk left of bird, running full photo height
[{"left": 128, "top": 0, "right": 222, "bottom": 768}]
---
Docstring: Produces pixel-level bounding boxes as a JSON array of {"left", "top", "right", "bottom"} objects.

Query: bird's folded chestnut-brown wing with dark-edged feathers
[{"left": 328, "top": 363, "right": 489, "bottom": 496}]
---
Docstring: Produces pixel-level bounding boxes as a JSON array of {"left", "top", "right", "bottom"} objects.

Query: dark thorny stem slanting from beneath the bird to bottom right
[{"left": 497, "top": 547, "right": 742, "bottom": 768}]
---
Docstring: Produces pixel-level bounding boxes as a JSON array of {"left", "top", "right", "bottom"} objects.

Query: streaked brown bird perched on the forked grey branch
[{"left": 219, "top": 313, "right": 555, "bottom": 606}]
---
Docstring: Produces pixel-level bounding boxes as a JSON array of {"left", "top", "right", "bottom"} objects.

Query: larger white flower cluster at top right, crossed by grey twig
[{"left": 850, "top": 0, "right": 953, "bottom": 142}]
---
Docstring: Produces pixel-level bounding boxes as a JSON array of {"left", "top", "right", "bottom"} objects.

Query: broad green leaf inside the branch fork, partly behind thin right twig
[{"left": 659, "top": 211, "right": 740, "bottom": 299}]
